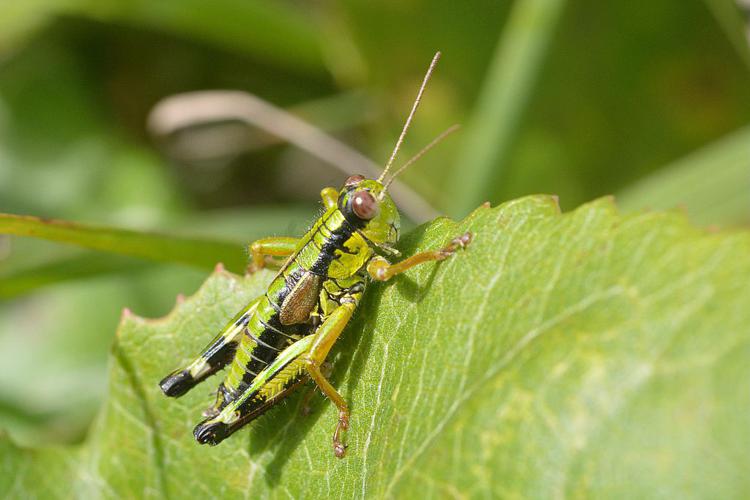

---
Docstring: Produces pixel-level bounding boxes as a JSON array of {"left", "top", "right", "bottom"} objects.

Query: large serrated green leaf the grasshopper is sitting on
[{"left": 0, "top": 196, "right": 750, "bottom": 498}]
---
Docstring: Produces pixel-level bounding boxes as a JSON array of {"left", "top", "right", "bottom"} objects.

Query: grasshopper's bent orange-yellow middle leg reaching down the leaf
[{"left": 302, "top": 299, "right": 356, "bottom": 458}]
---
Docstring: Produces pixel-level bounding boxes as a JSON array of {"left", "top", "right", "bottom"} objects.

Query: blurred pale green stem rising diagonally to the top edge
[{"left": 450, "top": 0, "right": 565, "bottom": 214}]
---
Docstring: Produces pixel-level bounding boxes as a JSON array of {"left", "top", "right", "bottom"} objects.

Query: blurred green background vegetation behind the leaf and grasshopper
[{"left": 0, "top": 0, "right": 750, "bottom": 444}]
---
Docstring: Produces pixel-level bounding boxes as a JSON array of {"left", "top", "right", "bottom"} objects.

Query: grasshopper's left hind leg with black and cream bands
[{"left": 159, "top": 297, "right": 261, "bottom": 397}]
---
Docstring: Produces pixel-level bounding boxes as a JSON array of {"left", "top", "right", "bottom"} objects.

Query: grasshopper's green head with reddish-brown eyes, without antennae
[{"left": 338, "top": 175, "right": 401, "bottom": 247}]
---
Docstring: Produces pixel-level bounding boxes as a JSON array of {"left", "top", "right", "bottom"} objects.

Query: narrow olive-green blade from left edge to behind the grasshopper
[{"left": 0, "top": 214, "right": 247, "bottom": 272}]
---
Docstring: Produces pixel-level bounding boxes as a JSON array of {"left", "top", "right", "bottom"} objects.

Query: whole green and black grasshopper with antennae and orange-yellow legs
[{"left": 159, "top": 52, "right": 472, "bottom": 457}]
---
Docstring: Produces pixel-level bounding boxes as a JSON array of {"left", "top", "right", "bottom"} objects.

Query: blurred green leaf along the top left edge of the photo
[{"left": 0, "top": 0, "right": 326, "bottom": 77}]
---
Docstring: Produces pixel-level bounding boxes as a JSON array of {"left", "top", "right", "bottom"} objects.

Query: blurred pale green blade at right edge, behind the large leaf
[{"left": 617, "top": 126, "right": 750, "bottom": 225}]
